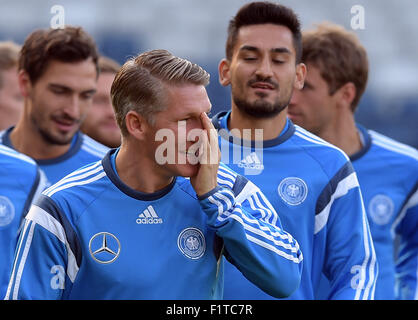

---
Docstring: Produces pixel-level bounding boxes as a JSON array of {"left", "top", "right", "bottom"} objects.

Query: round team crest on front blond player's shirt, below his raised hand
[{"left": 177, "top": 228, "right": 206, "bottom": 260}]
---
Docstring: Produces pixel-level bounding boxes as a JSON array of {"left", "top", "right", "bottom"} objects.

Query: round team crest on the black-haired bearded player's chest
[{"left": 277, "top": 177, "right": 308, "bottom": 206}]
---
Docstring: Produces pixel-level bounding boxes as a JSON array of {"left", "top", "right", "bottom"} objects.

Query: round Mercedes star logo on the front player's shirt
[{"left": 89, "top": 232, "right": 120, "bottom": 264}]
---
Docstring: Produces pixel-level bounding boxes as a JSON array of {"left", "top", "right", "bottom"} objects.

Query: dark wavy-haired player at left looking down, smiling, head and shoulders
[{"left": 0, "top": 26, "right": 108, "bottom": 189}]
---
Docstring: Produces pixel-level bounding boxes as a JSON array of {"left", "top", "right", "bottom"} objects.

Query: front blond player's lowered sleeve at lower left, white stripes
[{"left": 5, "top": 196, "right": 80, "bottom": 300}]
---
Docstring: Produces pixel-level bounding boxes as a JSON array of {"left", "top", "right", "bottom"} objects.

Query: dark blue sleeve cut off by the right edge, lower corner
[{"left": 395, "top": 189, "right": 418, "bottom": 300}]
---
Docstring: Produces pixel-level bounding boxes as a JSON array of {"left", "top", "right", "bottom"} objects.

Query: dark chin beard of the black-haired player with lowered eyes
[{"left": 233, "top": 96, "right": 290, "bottom": 119}]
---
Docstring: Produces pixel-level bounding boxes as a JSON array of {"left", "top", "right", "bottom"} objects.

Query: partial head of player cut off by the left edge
[{"left": 0, "top": 41, "right": 23, "bottom": 130}]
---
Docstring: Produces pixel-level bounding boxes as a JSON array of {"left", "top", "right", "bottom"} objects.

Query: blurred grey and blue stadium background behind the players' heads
[{"left": 0, "top": 0, "right": 418, "bottom": 148}]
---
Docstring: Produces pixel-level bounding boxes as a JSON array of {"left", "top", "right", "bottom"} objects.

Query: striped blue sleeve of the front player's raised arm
[{"left": 200, "top": 167, "right": 303, "bottom": 298}]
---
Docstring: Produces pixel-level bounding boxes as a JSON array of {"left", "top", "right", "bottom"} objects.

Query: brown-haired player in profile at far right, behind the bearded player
[{"left": 289, "top": 23, "right": 418, "bottom": 300}]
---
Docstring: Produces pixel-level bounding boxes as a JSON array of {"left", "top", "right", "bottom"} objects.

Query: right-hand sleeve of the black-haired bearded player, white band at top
[{"left": 315, "top": 162, "right": 378, "bottom": 300}]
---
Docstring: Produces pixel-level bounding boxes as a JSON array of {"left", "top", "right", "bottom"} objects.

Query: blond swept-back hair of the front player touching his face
[{"left": 110, "top": 50, "right": 210, "bottom": 136}]
